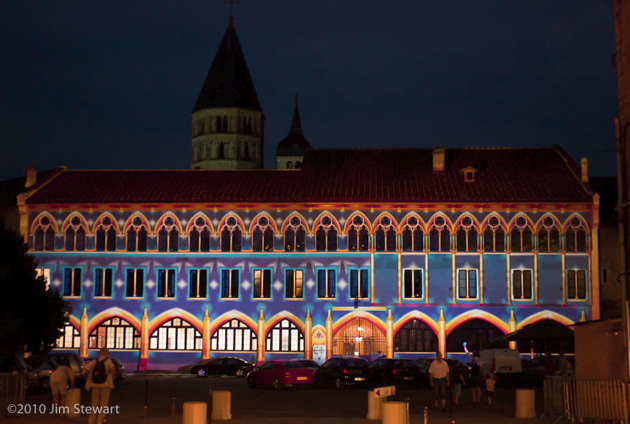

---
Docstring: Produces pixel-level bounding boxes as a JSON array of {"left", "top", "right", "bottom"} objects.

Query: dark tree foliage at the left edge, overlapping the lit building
[{"left": 0, "top": 229, "right": 71, "bottom": 354}]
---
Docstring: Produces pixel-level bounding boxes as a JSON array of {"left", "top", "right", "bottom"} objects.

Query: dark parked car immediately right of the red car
[{"left": 315, "top": 356, "right": 369, "bottom": 389}]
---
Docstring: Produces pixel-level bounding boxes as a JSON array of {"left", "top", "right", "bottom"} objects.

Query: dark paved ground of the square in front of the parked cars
[{"left": 17, "top": 373, "right": 543, "bottom": 423}]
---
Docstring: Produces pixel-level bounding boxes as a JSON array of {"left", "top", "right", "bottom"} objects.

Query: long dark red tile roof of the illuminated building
[{"left": 27, "top": 147, "right": 593, "bottom": 204}]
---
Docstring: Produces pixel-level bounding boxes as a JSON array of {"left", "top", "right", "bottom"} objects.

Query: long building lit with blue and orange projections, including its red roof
[{"left": 18, "top": 21, "right": 599, "bottom": 369}]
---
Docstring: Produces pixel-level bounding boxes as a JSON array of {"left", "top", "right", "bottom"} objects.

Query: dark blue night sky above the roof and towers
[{"left": 0, "top": 0, "right": 617, "bottom": 180}]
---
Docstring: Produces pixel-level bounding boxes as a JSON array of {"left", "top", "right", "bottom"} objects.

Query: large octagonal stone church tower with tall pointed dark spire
[{"left": 191, "top": 17, "right": 265, "bottom": 169}]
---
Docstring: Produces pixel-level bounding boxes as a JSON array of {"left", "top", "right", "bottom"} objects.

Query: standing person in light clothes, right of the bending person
[{"left": 85, "top": 347, "right": 116, "bottom": 424}]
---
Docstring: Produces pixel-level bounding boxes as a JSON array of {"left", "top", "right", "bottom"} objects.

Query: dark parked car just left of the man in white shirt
[{"left": 368, "top": 358, "right": 420, "bottom": 388}]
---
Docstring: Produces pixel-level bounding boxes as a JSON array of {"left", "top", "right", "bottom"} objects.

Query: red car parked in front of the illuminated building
[{"left": 247, "top": 361, "right": 315, "bottom": 389}]
